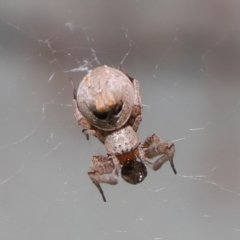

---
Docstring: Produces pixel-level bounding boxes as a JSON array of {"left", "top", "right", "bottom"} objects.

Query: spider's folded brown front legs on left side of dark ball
[{"left": 88, "top": 155, "right": 120, "bottom": 202}]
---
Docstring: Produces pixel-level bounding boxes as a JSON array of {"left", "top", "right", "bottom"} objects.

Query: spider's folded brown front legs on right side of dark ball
[{"left": 142, "top": 134, "right": 177, "bottom": 174}]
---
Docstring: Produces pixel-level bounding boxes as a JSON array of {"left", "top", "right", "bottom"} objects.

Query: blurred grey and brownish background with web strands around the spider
[{"left": 0, "top": 0, "right": 240, "bottom": 240}]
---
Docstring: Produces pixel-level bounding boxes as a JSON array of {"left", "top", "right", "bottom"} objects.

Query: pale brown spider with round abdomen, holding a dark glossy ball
[{"left": 72, "top": 66, "right": 177, "bottom": 202}]
